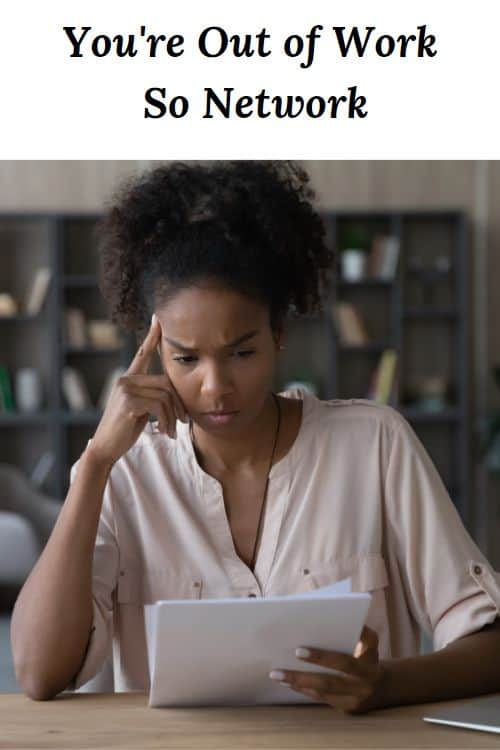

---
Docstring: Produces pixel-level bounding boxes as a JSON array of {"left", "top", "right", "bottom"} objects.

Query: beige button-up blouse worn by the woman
[{"left": 68, "top": 390, "right": 500, "bottom": 691}]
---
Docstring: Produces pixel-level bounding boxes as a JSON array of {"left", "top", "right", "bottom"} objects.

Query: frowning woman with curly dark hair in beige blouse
[{"left": 12, "top": 162, "right": 500, "bottom": 713}]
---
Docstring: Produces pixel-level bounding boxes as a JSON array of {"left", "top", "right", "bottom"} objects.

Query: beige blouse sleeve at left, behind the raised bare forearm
[{"left": 66, "top": 452, "right": 119, "bottom": 690}]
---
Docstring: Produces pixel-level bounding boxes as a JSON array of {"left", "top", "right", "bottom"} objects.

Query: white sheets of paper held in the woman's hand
[{"left": 145, "top": 579, "right": 371, "bottom": 706}]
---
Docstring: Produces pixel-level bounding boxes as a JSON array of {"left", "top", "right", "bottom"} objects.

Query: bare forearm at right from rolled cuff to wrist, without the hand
[{"left": 377, "top": 619, "right": 500, "bottom": 708}]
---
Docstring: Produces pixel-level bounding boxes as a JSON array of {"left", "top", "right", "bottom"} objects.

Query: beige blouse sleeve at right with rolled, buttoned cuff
[{"left": 385, "top": 412, "right": 500, "bottom": 650}]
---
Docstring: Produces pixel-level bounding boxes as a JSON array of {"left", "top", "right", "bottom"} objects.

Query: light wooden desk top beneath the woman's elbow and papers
[{"left": 0, "top": 693, "right": 500, "bottom": 750}]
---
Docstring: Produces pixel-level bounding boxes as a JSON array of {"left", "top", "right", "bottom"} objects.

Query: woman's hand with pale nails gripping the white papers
[{"left": 270, "top": 626, "right": 384, "bottom": 714}]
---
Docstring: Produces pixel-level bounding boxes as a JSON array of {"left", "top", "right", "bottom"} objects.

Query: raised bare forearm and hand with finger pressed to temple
[{"left": 11, "top": 316, "right": 187, "bottom": 700}]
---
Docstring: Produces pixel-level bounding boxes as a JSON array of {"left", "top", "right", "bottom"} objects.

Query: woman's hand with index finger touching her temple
[{"left": 89, "top": 315, "right": 188, "bottom": 464}]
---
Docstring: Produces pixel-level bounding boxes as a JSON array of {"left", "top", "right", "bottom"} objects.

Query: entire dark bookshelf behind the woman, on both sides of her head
[{"left": 0, "top": 211, "right": 471, "bottom": 536}]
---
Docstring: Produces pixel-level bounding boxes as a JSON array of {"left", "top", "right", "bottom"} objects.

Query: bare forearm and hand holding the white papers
[{"left": 269, "top": 619, "right": 500, "bottom": 714}]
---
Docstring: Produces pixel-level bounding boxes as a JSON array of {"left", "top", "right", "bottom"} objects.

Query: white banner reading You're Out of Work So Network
[{"left": 0, "top": 0, "right": 494, "bottom": 160}]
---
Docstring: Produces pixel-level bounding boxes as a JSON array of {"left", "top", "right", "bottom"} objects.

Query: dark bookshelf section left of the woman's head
[{"left": 0, "top": 214, "right": 134, "bottom": 500}]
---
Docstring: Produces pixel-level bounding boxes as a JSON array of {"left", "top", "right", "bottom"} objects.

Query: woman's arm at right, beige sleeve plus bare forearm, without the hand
[{"left": 378, "top": 414, "right": 500, "bottom": 705}]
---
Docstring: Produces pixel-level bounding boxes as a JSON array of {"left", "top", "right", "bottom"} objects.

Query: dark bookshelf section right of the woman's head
[{"left": 323, "top": 211, "right": 473, "bottom": 530}]
